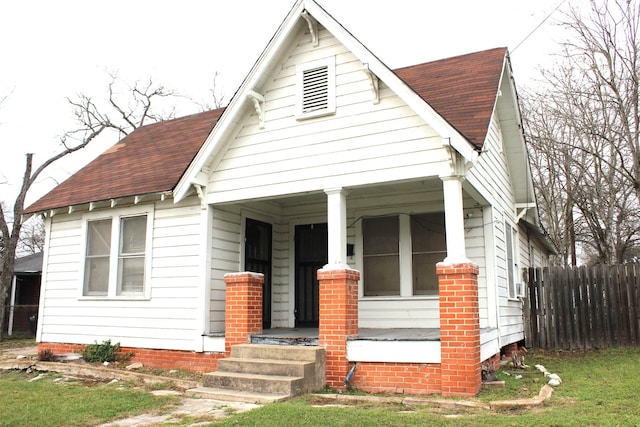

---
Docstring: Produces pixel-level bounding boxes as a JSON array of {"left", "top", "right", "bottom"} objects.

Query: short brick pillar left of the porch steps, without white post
[{"left": 224, "top": 272, "right": 264, "bottom": 353}]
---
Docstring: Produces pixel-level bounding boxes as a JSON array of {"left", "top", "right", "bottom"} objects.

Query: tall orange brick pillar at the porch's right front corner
[{"left": 436, "top": 262, "right": 482, "bottom": 396}]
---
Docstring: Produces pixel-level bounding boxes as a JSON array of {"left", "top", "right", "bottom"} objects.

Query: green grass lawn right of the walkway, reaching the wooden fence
[{"left": 215, "top": 348, "right": 640, "bottom": 427}]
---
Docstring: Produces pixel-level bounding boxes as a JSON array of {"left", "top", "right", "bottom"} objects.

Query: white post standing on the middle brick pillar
[{"left": 324, "top": 188, "right": 348, "bottom": 269}]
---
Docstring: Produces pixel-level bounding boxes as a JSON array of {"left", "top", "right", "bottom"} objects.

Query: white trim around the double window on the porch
[{"left": 355, "top": 208, "right": 444, "bottom": 301}]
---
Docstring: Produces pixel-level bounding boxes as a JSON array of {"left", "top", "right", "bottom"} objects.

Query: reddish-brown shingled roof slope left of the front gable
[{"left": 25, "top": 109, "right": 223, "bottom": 213}]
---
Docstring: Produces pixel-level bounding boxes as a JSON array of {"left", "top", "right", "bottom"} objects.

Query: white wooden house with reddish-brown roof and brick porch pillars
[{"left": 27, "top": 0, "right": 548, "bottom": 395}]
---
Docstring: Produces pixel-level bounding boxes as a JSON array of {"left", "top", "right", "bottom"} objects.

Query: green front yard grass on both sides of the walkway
[{"left": 0, "top": 340, "right": 640, "bottom": 427}]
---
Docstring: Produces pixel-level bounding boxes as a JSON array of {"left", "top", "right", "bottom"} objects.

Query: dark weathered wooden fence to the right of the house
[{"left": 525, "top": 264, "right": 640, "bottom": 349}]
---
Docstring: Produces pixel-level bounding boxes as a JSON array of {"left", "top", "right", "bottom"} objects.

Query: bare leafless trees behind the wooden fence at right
[{"left": 523, "top": 0, "right": 640, "bottom": 265}]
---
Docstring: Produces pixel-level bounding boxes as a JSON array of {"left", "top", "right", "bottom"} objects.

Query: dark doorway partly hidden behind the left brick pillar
[{"left": 244, "top": 218, "right": 271, "bottom": 329}]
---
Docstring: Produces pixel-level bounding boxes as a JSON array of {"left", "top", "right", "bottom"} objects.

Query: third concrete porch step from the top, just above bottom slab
[{"left": 202, "top": 371, "right": 306, "bottom": 396}]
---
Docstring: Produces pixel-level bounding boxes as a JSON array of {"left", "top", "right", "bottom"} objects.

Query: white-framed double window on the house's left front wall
[{"left": 83, "top": 213, "right": 151, "bottom": 297}]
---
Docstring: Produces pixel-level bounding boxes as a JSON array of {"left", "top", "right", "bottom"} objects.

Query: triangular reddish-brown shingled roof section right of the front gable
[{"left": 394, "top": 48, "right": 507, "bottom": 149}]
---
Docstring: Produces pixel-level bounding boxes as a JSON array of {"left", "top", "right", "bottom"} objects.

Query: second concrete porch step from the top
[{"left": 218, "top": 357, "right": 315, "bottom": 377}]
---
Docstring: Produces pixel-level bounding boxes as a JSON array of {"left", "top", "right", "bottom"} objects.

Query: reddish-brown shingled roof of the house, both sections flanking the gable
[{"left": 25, "top": 48, "right": 507, "bottom": 213}]
